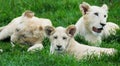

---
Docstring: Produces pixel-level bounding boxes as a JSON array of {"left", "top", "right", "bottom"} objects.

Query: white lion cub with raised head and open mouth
[{"left": 75, "top": 2, "right": 119, "bottom": 46}]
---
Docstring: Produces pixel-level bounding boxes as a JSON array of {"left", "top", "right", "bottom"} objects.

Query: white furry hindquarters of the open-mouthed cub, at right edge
[{"left": 102, "top": 22, "right": 120, "bottom": 38}]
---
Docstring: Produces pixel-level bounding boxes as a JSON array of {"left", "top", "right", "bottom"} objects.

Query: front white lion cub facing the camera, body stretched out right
[{"left": 45, "top": 25, "right": 116, "bottom": 59}]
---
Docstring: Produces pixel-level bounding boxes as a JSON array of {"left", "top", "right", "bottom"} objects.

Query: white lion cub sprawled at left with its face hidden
[{"left": 0, "top": 11, "right": 52, "bottom": 51}]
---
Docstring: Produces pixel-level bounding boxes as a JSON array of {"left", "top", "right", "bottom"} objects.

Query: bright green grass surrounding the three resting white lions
[{"left": 0, "top": 0, "right": 120, "bottom": 66}]
